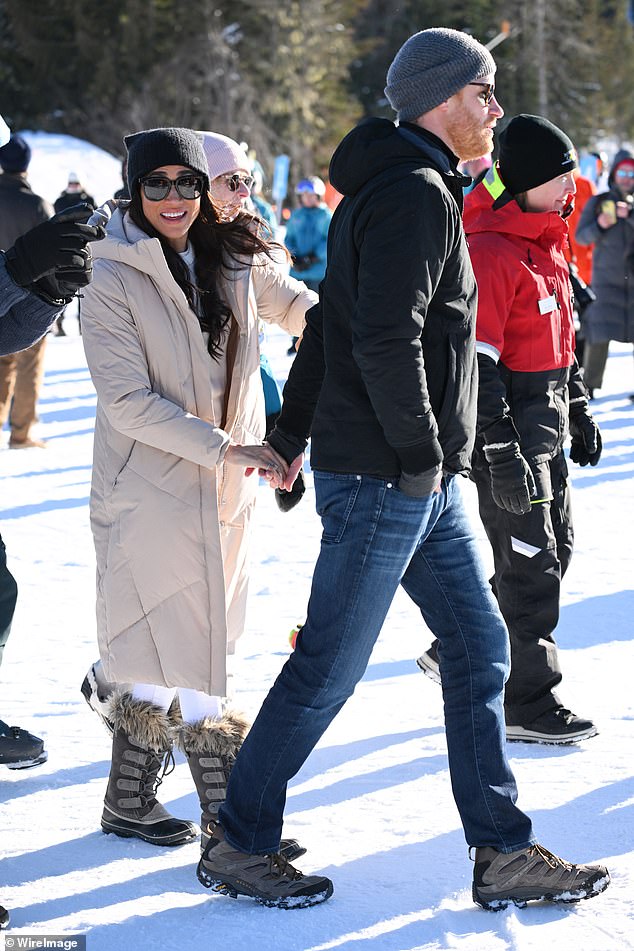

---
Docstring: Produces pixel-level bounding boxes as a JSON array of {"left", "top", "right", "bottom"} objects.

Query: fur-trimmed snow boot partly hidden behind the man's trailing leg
[{"left": 179, "top": 711, "right": 306, "bottom": 861}]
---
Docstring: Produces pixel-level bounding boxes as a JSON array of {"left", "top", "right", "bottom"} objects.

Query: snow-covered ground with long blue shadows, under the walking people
[{"left": 0, "top": 315, "right": 634, "bottom": 951}]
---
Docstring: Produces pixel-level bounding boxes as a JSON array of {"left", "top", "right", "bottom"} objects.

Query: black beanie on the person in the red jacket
[{"left": 499, "top": 115, "right": 579, "bottom": 195}]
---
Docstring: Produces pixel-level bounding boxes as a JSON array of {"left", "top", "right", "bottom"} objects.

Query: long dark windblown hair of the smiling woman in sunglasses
[{"left": 127, "top": 185, "right": 282, "bottom": 359}]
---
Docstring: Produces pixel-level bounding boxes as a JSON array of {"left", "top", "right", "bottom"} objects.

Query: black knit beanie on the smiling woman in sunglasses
[{"left": 123, "top": 128, "right": 209, "bottom": 195}]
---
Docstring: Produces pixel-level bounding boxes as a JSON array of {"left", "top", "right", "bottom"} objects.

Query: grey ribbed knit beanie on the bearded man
[{"left": 385, "top": 27, "right": 496, "bottom": 122}]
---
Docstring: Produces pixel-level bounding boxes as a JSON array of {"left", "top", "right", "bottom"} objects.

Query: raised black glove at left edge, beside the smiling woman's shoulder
[{"left": 5, "top": 205, "right": 105, "bottom": 297}]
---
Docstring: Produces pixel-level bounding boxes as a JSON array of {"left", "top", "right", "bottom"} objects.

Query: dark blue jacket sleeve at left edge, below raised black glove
[{"left": 0, "top": 251, "right": 62, "bottom": 355}]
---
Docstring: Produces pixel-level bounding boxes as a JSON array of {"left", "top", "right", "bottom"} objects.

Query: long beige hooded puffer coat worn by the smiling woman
[{"left": 82, "top": 211, "right": 316, "bottom": 696}]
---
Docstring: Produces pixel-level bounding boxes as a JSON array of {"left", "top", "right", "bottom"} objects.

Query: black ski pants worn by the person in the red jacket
[{"left": 472, "top": 452, "right": 573, "bottom": 726}]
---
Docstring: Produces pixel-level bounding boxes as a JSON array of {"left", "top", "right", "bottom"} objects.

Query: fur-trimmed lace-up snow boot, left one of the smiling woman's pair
[{"left": 101, "top": 690, "right": 198, "bottom": 845}]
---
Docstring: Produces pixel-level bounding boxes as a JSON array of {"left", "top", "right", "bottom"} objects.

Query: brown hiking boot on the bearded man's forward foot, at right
[{"left": 473, "top": 844, "right": 610, "bottom": 911}]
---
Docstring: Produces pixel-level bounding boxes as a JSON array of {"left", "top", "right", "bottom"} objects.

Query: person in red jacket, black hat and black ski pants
[{"left": 419, "top": 115, "right": 601, "bottom": 744}]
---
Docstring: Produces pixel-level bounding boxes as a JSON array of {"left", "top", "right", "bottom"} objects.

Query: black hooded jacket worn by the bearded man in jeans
[{"left": 272, "top": 119, "right": 477, "bottom": 478}]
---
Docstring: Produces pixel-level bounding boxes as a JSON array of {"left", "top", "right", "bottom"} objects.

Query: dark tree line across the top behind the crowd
[{"left": 0, "top": 0, "right": 634, "bottom": 174}]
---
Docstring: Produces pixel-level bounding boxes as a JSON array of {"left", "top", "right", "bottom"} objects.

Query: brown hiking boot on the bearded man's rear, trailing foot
[{"left": 197, "top": 825, "right": 333, "bottom": 908}]
